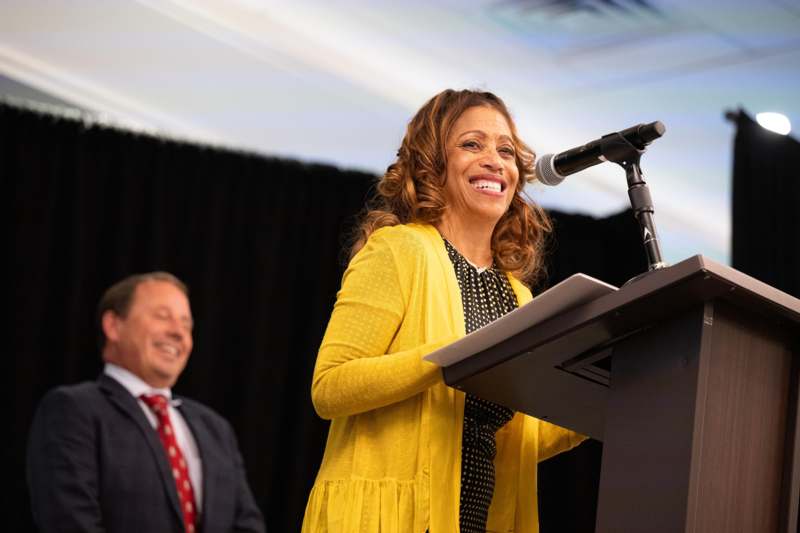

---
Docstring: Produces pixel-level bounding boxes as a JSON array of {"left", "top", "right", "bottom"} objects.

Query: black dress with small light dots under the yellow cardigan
[{"left": 445, "top": 240, "right": 517, "bottom": 533}]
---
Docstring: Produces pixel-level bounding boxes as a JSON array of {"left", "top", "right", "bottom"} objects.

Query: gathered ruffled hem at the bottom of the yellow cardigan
[{"left": 302, "top": 479, "right": 429, "bottom": 533}]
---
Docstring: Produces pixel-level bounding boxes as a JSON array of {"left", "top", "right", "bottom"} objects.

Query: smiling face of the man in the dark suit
[{"left": 102, "top": 280, "right": 192, "bottom": 388}]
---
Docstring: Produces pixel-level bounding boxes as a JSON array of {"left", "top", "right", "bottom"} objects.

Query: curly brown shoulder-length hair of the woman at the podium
[{"left": 350, "top": 89, "right": 552, "bottom": 284}]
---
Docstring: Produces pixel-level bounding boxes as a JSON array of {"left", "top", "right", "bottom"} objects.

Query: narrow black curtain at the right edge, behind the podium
[{"left": 731, "top": 111, "right": 800, "bottom": 298}]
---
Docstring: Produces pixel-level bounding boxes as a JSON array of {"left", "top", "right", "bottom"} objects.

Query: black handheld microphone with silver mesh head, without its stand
[{"left": 536, "top": 121, "right": 667, "bottom": 185}]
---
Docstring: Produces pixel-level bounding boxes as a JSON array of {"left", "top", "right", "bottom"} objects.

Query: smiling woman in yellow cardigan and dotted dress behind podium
[{"left": 303, "top": 90, "right": 584, "bottom": 533}]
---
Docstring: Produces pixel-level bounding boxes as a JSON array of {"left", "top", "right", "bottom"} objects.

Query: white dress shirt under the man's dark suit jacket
[{"left": 103, "top": 363, "right": 203, "bottom": 512}]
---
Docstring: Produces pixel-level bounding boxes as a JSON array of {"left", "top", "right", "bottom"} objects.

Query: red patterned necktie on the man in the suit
[{"left": 140, "top": 394, "right": 197, "bottom": 533}]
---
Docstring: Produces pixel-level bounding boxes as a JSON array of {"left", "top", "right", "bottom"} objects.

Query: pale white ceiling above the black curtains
[{"left": 0, "top": 0, "right": 800, "bottom": 262}]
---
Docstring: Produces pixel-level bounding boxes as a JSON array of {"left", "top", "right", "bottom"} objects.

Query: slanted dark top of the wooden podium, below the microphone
[{"left": 442, "top": 255, "right": 800, "bottom": 438}]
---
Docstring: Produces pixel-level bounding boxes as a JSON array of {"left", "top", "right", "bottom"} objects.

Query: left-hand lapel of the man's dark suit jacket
[{"left": 97, "top": 374, "right": 183, "bottom": 524}]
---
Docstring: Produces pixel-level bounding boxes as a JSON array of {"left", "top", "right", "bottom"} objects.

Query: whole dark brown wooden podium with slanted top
[{"left": 443, "top": 256, "right": 800, "bottom": 533}]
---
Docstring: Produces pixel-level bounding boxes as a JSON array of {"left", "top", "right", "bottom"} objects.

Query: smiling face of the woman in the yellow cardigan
[{"left": 442, "top": 106, "right": 519, "bottom": 228}]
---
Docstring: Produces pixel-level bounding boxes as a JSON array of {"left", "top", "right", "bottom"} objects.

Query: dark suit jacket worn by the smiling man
[{"left": 27, "top": 374, "right": 265, "bottom": 533}]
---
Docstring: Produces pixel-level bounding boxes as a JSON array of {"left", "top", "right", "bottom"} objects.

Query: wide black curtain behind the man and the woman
[{"left": 6, "top": 105, "right": 646, "bottom": 532}]
